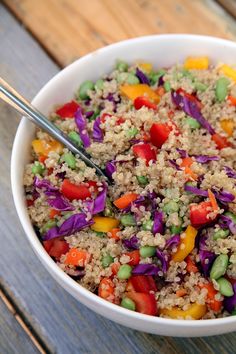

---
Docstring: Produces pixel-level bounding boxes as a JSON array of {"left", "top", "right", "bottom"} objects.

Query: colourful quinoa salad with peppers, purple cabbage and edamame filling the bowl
[{"left": 24, "top": 57, "right": 236, "bottom": 320}]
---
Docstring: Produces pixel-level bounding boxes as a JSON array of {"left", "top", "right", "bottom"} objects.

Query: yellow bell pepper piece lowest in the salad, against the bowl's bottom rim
[{"left": 160, "top": 302, "right": 207, "bottom": 320}]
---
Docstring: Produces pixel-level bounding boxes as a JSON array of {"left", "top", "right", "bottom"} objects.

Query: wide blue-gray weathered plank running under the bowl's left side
[{"left": 0, "top": 4, "right": 236, "bottom": 354}]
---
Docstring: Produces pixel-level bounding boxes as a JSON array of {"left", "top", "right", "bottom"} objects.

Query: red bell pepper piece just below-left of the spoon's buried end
[{"left": 61, "top": 179, "right": 91, "bottom": 200}]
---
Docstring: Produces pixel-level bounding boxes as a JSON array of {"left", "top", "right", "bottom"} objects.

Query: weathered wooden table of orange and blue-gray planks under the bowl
[{"left": 0, "top": 0, "right": 236, "bottom": 354}]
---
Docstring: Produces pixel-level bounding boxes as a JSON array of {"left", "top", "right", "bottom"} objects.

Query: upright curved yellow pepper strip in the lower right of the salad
[{"left": 172, "top": 225, "right": 197, "bottom": 262}]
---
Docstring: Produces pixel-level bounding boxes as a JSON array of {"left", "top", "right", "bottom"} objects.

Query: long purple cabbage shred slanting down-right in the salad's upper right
[{"left": 171, "top": 91, "right": 215, "bottom": 135}]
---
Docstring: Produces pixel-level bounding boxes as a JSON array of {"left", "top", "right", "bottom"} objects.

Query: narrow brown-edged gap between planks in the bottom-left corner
[{"left": 0, "top": 289, "right": 50, "bottom": 354}]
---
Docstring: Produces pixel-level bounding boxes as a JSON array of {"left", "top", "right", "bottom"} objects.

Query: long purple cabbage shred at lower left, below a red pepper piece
[{"left": 43, "top": 213, "right": 94, "bottom": 241}]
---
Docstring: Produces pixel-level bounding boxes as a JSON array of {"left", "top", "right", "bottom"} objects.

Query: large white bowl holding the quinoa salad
[{"left": 11, "top": 34, "right": 236, "bottom": 337}]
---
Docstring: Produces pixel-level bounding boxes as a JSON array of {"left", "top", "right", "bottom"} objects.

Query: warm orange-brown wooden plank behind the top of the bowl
[{"left": 4, "top": 0, "right": 236, "bottom": 66}]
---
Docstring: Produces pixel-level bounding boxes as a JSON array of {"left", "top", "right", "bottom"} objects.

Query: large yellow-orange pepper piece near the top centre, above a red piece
[{"left": 120, "top": 84, "right": 160, "bottom": 103}]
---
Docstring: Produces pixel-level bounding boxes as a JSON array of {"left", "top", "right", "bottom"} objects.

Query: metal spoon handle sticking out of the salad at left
[{"left": 0, "top": 77, "right": 111, "bottom": 183}]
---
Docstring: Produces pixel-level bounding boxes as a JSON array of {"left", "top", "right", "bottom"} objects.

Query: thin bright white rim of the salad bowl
[{"left": 11, "top": 33, "right": 236, "bottom": 329}]
